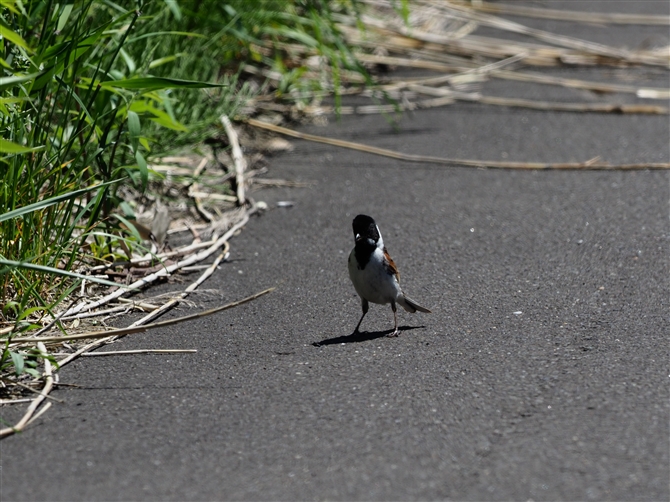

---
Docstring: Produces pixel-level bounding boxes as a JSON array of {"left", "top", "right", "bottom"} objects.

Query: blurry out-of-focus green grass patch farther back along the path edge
[{"left": 168, "top": 0, "right": 370, "bottom": 110}]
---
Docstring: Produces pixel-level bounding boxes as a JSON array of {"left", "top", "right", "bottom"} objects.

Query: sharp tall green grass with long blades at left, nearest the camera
[{"left": 0, "top": 0, "right": 228, "bottom": 324}]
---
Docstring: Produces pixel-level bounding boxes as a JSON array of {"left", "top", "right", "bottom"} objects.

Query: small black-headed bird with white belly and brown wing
[{"left": 348, "top": 214, "right": 430, "bottom": 336}]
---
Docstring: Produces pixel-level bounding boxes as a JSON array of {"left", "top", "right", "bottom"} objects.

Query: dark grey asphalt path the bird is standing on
[{"left": 0, "top": 2, "right": 670, "bottom": 501}]
